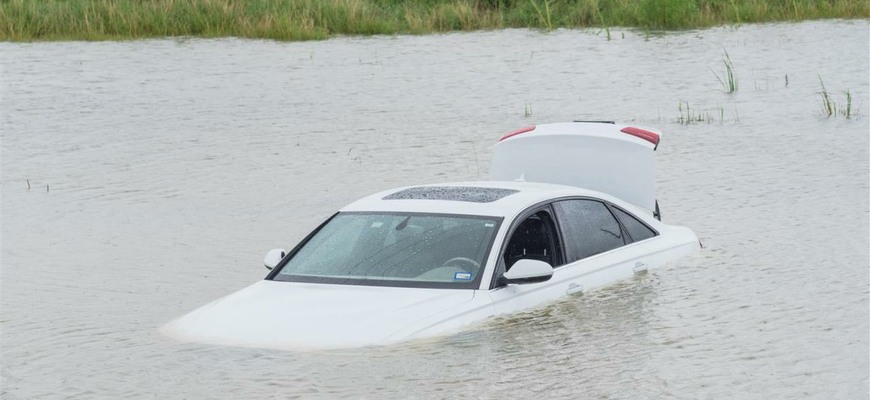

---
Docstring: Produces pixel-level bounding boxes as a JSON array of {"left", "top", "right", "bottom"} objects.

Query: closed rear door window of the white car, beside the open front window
[{"left": 554, "top": 199, "right": 626, "bottom": 262}]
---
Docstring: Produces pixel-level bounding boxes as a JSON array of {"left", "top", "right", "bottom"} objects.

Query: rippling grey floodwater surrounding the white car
[{"left": 0, "top": 21, "right": 870, "bottom": 399}]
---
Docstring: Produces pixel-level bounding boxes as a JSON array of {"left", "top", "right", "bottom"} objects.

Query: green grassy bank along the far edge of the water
[{"left": 0, "top": 0, "right": 870, "bottom": 41}]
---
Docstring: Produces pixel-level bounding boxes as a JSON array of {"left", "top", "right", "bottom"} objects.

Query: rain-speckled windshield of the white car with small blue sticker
[{"left": 272, "top": 213, "right": 501, "bottom": 288}]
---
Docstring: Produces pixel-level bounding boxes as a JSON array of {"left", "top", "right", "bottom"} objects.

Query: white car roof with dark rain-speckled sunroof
[{"left": 340, "top": 181, "right": 632, "bottom": 217}]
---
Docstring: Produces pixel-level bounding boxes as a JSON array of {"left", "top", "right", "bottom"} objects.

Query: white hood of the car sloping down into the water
[{"left": 161, "top": 280, "right": 475, "bottom": 349}]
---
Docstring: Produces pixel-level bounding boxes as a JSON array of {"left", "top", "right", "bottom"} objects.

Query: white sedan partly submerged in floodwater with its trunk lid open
[{"left": 163, "top": 122, "right": 699, "bottom": 349}]
